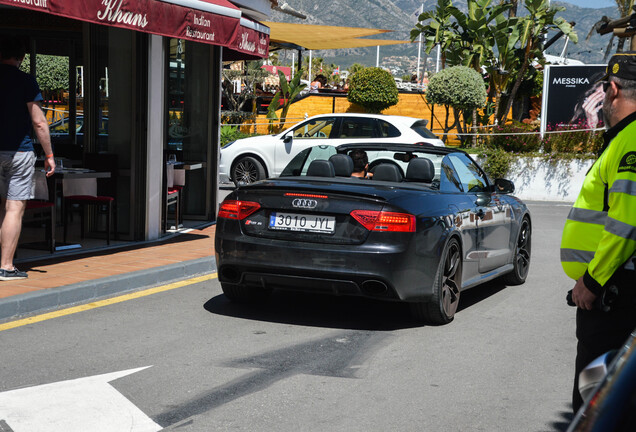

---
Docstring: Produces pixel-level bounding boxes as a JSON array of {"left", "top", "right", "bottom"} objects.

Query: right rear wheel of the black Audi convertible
[{"left": 411, "top": 238, "right": 462, "bottom": 325}]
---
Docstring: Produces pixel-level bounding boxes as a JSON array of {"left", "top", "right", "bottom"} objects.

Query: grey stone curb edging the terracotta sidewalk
[{"left": 0, "top": 257, "right": 216, "bottom": 322}]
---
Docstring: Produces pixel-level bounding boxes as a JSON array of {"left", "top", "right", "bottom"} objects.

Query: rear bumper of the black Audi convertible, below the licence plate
[{"left": 215, "top": 228, "right": 438, "bottom": 301}]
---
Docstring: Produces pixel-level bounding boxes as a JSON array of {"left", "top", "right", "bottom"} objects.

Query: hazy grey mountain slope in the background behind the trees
[{"left": 271, "top": 0, "right": 618, "bottom": 76}]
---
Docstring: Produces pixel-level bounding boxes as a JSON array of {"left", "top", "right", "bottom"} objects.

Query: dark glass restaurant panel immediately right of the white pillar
[{"left": 164, "top": 39, "right": 211, "bottom": 220}]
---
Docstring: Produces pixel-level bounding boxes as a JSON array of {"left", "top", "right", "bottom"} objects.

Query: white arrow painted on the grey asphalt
[{"left": 0, "top": 366, "right": 162, "bottom": 432}]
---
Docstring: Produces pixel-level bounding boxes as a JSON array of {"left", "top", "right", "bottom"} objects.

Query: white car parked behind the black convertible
[{"left": 219, "top": 113, "right": 444, "bottom": 184}]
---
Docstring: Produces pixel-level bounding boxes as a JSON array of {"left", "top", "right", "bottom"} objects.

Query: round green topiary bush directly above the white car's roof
[{"left": 347, "top": 67, "right": 398, "bottom": 114}]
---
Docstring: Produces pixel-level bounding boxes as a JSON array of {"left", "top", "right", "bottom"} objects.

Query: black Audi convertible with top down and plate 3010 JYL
[{"left": 215, "top": 144, "right": 532, "bottom": 324}]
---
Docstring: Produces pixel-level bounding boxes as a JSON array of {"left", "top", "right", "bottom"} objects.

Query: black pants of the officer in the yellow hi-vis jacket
[{"left": 572, "top": 279, "right": 636, "bottom": 414}]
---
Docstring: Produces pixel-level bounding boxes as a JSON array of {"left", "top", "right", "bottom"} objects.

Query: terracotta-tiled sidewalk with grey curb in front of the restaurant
[{"left": 0, "top": 225, "right": 216, "bottom": 321}]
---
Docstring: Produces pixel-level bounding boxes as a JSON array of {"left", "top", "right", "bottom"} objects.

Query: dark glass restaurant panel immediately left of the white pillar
[{"left": 87, "top": 26, "right": 145, "bottom": 240}]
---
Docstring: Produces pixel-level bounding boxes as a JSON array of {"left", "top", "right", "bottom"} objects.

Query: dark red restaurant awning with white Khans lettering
[{"left": 0, "top": 0, "right": 269, "bottom": 57}]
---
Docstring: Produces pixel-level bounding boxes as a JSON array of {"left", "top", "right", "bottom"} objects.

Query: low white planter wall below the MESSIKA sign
[{"left": 480, "top": 157, "right": 594, "bottom": 203}]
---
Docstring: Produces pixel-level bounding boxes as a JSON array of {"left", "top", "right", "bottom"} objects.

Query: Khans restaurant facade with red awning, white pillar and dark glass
[{"left": 0, "top": 0, "right": 272, "bottom": 246}]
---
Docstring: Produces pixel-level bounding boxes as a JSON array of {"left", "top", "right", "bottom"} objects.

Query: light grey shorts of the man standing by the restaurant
[{"left": 0, "top": 151, "right": 35, "bottom": 201}]
